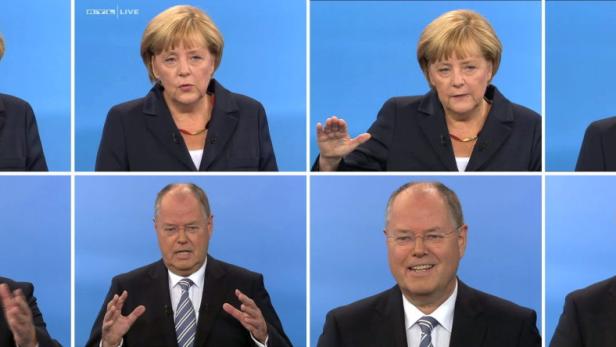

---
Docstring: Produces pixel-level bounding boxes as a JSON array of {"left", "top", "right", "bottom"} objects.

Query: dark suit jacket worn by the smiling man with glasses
[{"left": 317, "top": 281, "right": 541, "bottom": 347}]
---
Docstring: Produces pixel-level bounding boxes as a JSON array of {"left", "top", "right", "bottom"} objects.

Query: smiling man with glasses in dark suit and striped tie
[{"left": 318, "top": 183, "right": 541, "bottom": 347}]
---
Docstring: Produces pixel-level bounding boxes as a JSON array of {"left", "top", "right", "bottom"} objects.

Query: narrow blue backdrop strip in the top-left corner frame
[{"left": 0, "top": 0, "right": 71, "bottom": 171}]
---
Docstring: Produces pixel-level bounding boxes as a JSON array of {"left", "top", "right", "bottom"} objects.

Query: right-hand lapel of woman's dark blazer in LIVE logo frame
[{"left": 199, "top": 79, "right": 239, "bottom": 171}]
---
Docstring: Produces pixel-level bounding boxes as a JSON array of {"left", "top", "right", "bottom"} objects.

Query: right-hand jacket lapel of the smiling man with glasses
[{"left": 449, "top": 280, "right": 486, "bottom": 347}]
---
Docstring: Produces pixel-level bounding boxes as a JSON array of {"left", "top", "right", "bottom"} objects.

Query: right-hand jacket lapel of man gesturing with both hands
[{"left": 195, "top": 255, "right": 228, "bottom": 347}]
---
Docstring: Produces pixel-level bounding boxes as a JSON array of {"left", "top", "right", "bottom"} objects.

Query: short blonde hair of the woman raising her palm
[{"left": 417, "top": 10, "right": 503, "bottom": 81}]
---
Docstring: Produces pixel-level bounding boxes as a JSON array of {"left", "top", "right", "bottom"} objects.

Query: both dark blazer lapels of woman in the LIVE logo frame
[{"left": 143, "top": 79, "right": 239, "bottom": 171}]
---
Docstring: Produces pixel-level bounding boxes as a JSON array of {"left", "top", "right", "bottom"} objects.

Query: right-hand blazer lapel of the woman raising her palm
[{"left": 466, "top": 86, "right": 514, "bottom": 171}]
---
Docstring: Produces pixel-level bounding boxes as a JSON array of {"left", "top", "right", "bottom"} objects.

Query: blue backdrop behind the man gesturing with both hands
[{"left": 75, "top": 176, "right": 306, "bottom": 346}]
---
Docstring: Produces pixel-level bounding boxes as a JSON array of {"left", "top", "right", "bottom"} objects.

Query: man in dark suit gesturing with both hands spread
[{"left": 86, "top": 184, "right": 291, "bottom": 347}]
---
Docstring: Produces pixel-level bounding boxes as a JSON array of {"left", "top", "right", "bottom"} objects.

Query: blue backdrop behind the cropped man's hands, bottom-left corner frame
[{"left": 0, "top": 176, "right": 71, "bottom": 346}]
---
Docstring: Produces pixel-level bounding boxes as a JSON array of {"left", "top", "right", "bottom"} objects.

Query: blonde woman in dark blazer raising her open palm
[{"left": 313, "top": 10, "right": 541, "bottom": 171}]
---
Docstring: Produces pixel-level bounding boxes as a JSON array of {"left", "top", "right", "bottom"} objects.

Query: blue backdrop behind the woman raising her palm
[{"left": 310, "top": 1, "right": 541, "bottom": 160}]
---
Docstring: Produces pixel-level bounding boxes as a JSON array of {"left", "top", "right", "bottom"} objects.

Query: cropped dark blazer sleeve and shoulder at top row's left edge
[{"left": 0, "top": 94, "right": 47, "bottom": 171}]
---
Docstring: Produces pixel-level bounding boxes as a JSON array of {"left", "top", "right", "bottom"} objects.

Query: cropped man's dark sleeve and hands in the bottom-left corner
[{"left": 0, "top": 277, "right": 60, "bottom": 347}]
